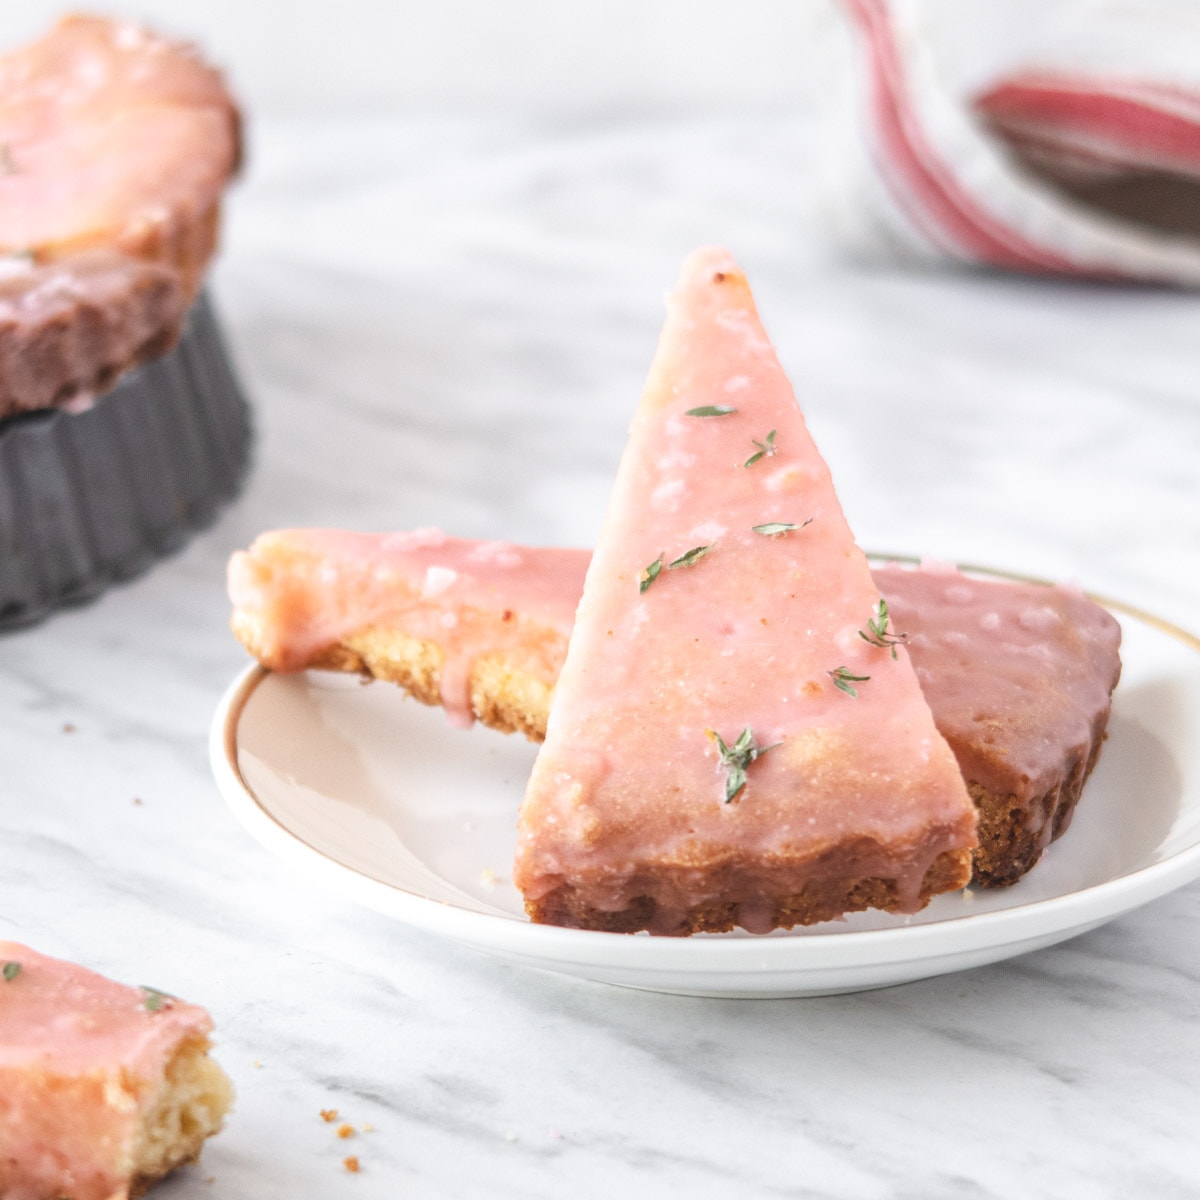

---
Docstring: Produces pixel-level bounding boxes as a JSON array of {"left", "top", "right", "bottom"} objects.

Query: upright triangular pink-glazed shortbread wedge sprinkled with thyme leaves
[{"left": 514, "top": 250, "right": 976, "bottom": 934}]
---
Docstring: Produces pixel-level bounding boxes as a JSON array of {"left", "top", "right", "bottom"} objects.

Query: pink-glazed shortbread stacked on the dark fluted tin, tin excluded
[{"left": 0, "top": 17, "right": 240, "bottom": 418}]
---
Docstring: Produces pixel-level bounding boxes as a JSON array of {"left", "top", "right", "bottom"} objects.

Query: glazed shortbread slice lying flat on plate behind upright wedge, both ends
[{"left": 229, "top": 529, "right": 1121, "bottom": 887}]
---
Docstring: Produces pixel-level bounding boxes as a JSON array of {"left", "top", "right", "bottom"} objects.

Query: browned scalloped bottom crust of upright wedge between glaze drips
[{"left": 526, "top": 850, "right": 971, "bottom": 937}]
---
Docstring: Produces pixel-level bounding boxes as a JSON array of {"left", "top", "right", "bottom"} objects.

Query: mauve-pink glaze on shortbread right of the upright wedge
[{"left": 875, "top": 565, "right": 1121, "bottom": 825}]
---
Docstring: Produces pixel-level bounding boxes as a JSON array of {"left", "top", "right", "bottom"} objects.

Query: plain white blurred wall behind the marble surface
[{"left": 2, "top": 0, "right": 833, "bottom": 115}]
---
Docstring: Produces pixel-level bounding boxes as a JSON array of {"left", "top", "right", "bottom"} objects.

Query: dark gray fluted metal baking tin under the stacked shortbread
[{"left": 0, "top": 295, "right": 252, "bottom": 630}]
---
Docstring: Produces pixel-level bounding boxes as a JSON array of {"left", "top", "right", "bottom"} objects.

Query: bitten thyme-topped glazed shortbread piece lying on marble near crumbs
[{"left": 0, "top": 942, "right": 233, "bottom": 1200}]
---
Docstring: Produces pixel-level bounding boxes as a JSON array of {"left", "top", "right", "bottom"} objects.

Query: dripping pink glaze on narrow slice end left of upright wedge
[{"left": 229, "top": 529, "right": 588, "bottom": 725}]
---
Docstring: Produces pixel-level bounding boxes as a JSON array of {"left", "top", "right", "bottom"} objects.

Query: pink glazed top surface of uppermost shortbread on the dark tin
[{"left": 0, "top": 17, "right": 238, "bottom": 274}]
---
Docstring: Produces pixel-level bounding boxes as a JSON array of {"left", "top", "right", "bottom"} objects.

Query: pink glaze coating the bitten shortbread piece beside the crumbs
[{"left": 0, "top": 942, "right": 212, "bottom": 1200}]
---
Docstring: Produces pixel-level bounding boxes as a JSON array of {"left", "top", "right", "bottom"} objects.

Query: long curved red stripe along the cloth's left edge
[{"left": 842, "top": 0, "right": 1116, "bottom": 278}]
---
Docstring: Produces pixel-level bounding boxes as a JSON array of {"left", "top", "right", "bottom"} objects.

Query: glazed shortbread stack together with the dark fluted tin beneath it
[{"left": 0, "top": 17, "right": 250, "bottom": 630}]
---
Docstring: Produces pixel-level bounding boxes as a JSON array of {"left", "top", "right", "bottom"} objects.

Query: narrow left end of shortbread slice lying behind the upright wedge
[{"left": 228, "top": 529, "right": 588, "bottom": 738}]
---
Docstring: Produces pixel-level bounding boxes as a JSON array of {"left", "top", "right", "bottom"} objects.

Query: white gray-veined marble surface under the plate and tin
[{"left": 0, "top": 113, "right": 1200, "bottom": 1200}]
